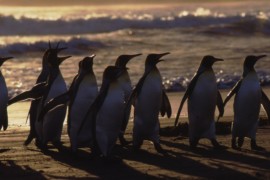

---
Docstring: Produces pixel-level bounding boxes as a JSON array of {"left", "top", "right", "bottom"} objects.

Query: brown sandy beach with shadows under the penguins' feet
[{"left": 0, "top": 88, "right": 270, "bottom": 179}]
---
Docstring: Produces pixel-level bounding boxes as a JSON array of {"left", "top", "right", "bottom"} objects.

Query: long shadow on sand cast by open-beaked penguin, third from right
[{"left": 118, "top": 138, "right": 255, "bottom": 179}]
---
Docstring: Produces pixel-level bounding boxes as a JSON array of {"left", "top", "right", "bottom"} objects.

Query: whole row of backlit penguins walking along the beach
[{"left": 0, "top": 44, "right": 270, "bottom": 157}]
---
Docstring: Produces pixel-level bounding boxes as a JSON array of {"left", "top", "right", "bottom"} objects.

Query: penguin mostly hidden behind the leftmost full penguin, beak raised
[{"left": 24, "top": 42, "right": 68, "bottom": 146}]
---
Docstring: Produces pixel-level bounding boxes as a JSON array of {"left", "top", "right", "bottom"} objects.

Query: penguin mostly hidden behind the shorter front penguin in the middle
[{"left": 115, "top": 54, "right": 142, "bottom": 145}]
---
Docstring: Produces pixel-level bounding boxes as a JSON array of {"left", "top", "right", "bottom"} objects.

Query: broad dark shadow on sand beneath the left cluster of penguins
[{"left": 34, "top": 145, "right": 158, "bottom": 179}]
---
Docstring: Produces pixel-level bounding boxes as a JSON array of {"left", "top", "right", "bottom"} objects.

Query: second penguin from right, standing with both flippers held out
[{"left": 175, "top": 55, "right": 225, "bottom": 149}]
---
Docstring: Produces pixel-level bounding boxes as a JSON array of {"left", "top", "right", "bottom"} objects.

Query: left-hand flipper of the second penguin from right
[{"left": 174, "top": 72, "right": 202, "bottom": 126}]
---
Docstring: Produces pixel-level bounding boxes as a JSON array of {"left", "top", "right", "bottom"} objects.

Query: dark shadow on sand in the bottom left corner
[{"left": 0, "top": 160, "right": 46, "bottom": 179}]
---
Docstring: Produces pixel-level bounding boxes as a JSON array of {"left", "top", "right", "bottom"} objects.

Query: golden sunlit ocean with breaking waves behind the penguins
[{"left": 0, "top": 1, "right": 270, "bottom": 96}]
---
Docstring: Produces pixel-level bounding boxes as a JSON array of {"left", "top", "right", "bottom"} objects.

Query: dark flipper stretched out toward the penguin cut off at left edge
[{"left": 8, "top": 82, "right": 47, "bottom": 106}]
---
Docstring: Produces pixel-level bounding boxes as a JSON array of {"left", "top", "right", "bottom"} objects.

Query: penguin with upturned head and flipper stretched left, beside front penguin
[{"left": 39, "top": 55, "right": 98, "bottom": 152}]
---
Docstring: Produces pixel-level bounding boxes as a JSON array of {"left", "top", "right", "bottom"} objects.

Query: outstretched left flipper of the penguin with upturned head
[{"left": 38, "top": 91, "right": 70, "bottom": 121}]
